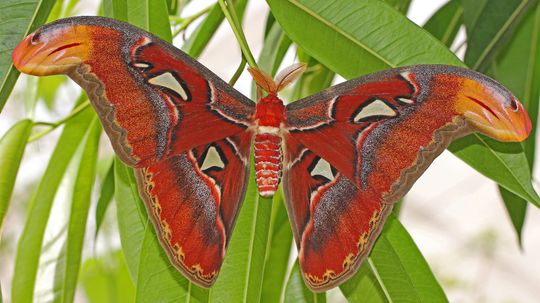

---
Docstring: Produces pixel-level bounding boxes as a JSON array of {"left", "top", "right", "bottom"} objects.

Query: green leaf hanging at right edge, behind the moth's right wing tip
[{"left": 491, "top": 4, "right": 540, "bottom": 243}]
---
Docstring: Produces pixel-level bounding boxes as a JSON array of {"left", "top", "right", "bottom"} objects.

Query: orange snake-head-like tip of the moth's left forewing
[{"left": 12, "top": 22, "right": 92, "bottom": 76}]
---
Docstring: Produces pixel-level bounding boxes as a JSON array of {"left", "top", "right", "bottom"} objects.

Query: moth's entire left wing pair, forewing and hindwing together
[{"left": 13, "top": 17, "right": 255, "bottom": 287}]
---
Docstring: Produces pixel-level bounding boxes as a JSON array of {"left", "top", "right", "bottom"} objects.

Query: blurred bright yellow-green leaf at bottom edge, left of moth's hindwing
[{"left": 80, "top": 251, "right": 135, "bottom": 303}]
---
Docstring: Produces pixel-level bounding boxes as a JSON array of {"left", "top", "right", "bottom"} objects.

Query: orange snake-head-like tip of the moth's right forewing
[{"left": 456, "top": 73, "right": 532, "bottom": 141}]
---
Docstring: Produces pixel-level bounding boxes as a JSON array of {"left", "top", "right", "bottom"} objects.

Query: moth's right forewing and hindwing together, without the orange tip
[{"left": 283, "top": 66, "right": 476, "bottom": 291}]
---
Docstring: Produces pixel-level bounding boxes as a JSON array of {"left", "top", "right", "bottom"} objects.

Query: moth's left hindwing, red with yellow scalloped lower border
[{"left": 137, "top": 132, "right": 251, "bottom": 287}]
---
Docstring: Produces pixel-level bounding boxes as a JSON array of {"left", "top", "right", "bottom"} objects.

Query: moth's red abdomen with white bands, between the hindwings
[{"left": 255, "top": 133, "right": 283, "bottom": 197}]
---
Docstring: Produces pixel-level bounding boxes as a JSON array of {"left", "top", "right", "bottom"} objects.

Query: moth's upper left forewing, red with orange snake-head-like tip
[{"left": 13, "top": 17, "right": 255, "bottom": 167}]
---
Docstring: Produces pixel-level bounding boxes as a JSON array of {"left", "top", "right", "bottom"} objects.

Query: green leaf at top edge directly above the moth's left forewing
[{"left": 127, "top": 0, "right": 172, "bottom": 42}]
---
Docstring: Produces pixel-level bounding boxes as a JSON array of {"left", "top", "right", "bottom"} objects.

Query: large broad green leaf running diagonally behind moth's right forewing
[{"left": 268, "top": 0, "right": 540, "bottom": 205}]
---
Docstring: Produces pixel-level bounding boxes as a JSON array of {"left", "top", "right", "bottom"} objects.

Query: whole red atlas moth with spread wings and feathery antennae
[{"left": 13, "top": 17, "right": 531, "bottom": 291}]
